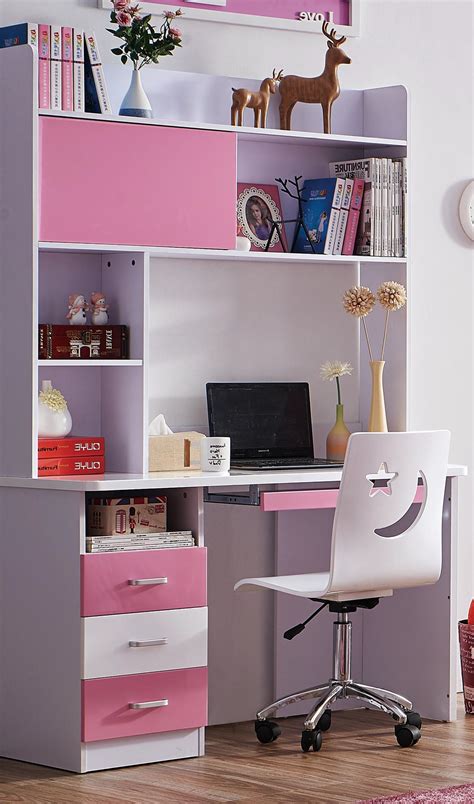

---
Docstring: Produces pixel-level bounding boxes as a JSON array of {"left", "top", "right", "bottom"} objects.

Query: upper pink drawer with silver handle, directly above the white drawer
[{"left": 81, "top": 547, "right": 207, "bottom": 617}]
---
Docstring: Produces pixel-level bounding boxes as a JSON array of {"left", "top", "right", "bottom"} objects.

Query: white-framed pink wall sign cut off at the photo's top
[{"left": 97, "top": 0, "right": 360, "bottom": 36}]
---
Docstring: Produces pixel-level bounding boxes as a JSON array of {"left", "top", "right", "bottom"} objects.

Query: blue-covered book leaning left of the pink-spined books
[{"left": 292, "top": 178, "right": 344, "bottom": 254}]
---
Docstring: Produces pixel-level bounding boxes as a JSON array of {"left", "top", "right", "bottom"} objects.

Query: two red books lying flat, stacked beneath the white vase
[{"left": 38, "top": 436, "right": 105, "bottom": 477}]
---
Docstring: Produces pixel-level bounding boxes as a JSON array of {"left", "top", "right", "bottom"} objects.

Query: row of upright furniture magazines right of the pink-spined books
[{"left": 329, "top": 157, "right": 407, "bottom": 257}]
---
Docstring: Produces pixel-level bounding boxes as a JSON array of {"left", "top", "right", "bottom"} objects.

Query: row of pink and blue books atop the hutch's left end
[{"left": 0, "top": 22, "right": 112, "bottom": 114}]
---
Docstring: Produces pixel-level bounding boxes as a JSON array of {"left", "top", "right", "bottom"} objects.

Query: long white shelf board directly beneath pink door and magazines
[{"left": 39, "top": 242, "right": 406, "bottom": 264}]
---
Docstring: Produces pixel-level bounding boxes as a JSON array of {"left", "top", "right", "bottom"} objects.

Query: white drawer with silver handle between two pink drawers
[{"left": 82, "top": 607, "right": 207, "bottom": 678}]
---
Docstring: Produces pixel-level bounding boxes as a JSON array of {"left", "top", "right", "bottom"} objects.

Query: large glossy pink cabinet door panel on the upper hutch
[{"left": 39, "top": 117, "right": 237, "bottom": 249}]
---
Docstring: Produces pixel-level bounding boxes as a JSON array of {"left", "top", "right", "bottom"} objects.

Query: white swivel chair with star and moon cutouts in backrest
[{"left": 235, "top": 430, "right": 450, "bottom": 751}]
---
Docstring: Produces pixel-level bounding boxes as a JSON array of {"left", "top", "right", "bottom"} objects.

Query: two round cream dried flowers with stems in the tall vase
[{"left": 342, "top": 281, "right": 407, "bottom": 362}]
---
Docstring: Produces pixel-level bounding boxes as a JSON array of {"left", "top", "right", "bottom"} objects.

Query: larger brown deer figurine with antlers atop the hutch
[{"left": 280, "top": 21, "right": 351, "bottom": 134}]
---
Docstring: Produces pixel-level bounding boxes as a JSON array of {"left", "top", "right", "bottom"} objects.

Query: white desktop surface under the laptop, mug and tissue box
[{"left": 0, "top": 464, "right": 467, "bottom": 492}]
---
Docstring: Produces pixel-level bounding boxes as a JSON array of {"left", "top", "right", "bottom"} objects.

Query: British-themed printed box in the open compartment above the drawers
[{"left": 87, "top": 496, "right": 166, "bottom": 536}]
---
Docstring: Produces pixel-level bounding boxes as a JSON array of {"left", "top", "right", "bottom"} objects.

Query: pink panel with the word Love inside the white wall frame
[{"left": 143, "top": 0, "right": 355, "bottom": 28}]
